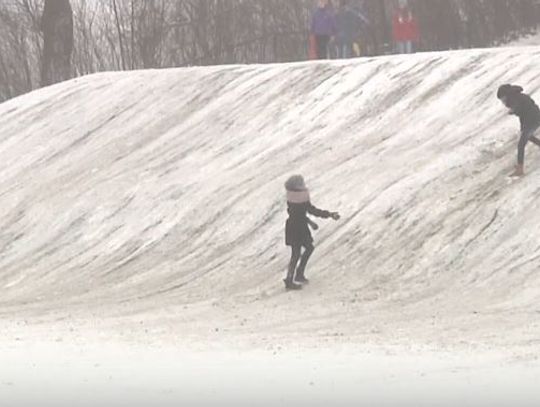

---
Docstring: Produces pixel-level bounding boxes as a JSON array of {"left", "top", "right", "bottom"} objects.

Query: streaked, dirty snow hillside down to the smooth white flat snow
[{"left": 0, "top": 48, "right": 540, "bottom": 346}]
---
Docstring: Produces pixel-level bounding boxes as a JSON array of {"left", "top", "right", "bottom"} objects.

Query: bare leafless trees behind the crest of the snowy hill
[{"left": 0, "top": 0, "right": 540, "bottom": 101}]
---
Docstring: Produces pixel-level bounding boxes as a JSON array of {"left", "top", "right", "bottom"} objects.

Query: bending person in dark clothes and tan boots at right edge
[{"left": 497, "top": 84, "right": 540, "bottom": 177}]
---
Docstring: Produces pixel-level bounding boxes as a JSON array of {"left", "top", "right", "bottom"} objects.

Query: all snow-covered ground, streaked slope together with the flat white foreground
[{"left": 0, "top": 48, "right": 540, "bottom": 406}]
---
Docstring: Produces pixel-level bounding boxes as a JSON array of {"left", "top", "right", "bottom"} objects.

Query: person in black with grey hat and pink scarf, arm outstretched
[{"left": 284, "top": 175, "right": 340, "bottom": 290}]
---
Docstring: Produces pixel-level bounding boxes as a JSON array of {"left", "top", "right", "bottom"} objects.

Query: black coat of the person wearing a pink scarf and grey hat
[{"left": 285, "top": 202, "right": 331, "bottom": 247}]
